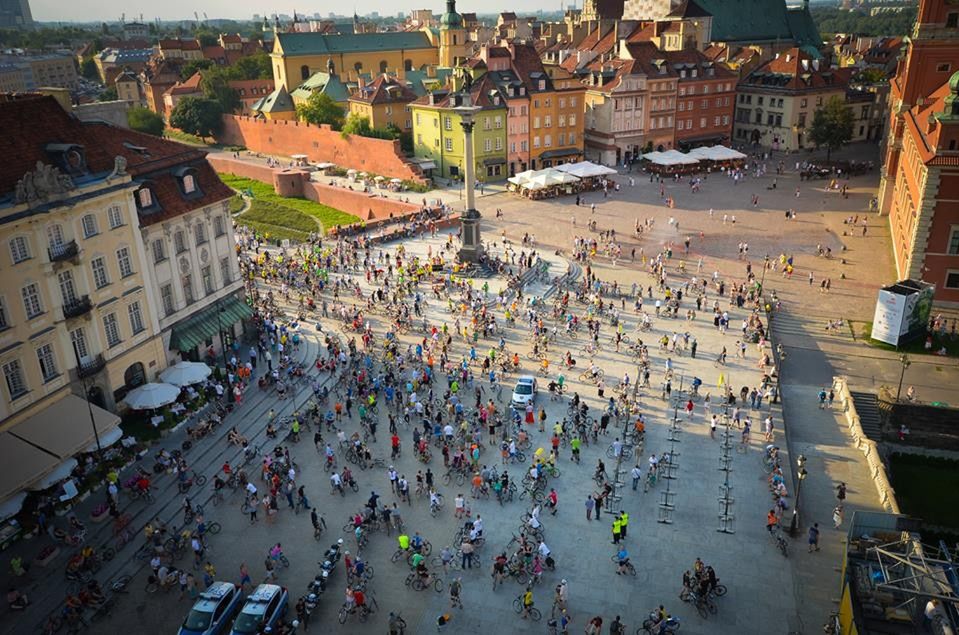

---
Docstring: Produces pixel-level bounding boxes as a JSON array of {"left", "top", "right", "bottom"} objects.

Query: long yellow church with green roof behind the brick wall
[{"left": 270, "top": 31, "right": 438, "bottom": 92}]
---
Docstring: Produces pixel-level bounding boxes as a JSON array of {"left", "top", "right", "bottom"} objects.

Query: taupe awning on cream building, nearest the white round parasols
[{"left": 9, "top": 394, "right": 120, "bottom": 461}]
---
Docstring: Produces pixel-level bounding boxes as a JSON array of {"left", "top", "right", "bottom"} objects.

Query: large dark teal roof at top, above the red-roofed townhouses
[{"left": 696, "top": 0, "right": 821, "bottom": 46}]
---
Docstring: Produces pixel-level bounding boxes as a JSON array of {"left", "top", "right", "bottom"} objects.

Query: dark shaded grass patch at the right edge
[{"left": 889, "top": 454, "right": 959, "bottom": 528}]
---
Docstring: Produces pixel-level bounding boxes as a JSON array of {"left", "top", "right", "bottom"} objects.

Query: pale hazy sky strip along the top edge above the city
[{"left": 30, "top": 0, "right": 573, "bottom": 22}]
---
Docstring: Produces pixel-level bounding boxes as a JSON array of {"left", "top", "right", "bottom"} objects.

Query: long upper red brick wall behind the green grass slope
[{"left": 223, "top": 115, "right": 420, "bottom": 179}]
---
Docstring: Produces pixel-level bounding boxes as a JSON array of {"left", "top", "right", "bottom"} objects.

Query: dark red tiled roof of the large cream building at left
[{"left": 0, "top": 95, "right": 233, "bottom": 225}]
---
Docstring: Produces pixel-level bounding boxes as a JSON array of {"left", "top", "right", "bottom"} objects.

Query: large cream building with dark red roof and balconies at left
[{"left": 0, "top": 95, "right": 248, "bottom": 502}]
